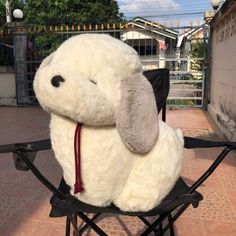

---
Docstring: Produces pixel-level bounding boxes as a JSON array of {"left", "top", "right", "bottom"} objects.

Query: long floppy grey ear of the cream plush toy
[{"left": 116, "top": 73, "right": 159, "bottom": 153}]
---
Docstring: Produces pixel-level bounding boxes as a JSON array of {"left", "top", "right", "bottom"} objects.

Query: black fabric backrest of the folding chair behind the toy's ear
[{"left": 143, "top": 68, "right": 170, "bottom": 112}]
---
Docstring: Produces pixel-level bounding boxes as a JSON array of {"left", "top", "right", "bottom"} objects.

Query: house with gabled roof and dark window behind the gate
[{"left": 121, "top": 17, "right": 179, "bottom": 69}]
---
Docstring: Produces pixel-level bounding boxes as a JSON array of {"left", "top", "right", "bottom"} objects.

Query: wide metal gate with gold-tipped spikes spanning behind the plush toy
[{"left": 10, "top": 22, "right": 208, "bottom": 107}]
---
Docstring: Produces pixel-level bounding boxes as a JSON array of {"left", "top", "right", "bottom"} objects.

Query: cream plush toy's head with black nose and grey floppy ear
[{"left": 34, "top": 34, "right": 158, "bottom": 153}]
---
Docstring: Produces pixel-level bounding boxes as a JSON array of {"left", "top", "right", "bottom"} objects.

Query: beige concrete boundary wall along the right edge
[{"left": 208, "top": 3, "right": 236, "bottom": 140}]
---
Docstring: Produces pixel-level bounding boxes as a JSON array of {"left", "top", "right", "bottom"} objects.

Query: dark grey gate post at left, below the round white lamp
[{"left": 11, "top": 23, "right": 30, "bottom": 105}]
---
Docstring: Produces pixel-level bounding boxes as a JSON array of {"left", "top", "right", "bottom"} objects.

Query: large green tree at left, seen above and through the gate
[{"left": 23, "top": 0, "right": 123, "bottom": 57}]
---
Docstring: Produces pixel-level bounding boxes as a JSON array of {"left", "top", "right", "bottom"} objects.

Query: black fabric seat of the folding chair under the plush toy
[{"left": 50, "top": 178, "right": 203, "bottom": 217}]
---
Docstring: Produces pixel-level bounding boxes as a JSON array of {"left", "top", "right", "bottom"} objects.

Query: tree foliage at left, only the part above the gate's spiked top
[{"left": 24, "top": 0, "right": 123, "bottom": 25}]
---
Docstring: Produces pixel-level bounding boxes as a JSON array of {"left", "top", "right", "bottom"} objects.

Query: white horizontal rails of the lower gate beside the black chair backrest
[{"left": 141, "top": 57, "right": 205, "bottom": 108}]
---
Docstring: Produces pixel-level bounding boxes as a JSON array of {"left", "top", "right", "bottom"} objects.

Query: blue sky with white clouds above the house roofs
[{"left": 118, "top": 0, "right": 212, "bottom": 26}]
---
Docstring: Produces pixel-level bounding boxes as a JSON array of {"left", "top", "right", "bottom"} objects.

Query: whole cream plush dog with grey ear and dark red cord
[{"left": 34, "top": 34, "right": 183, "bottom": 211}]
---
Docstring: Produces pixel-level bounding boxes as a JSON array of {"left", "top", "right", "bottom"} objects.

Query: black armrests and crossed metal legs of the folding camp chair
[{"left": 0, "top": 137, "right": 236, "bottom": 236}]
